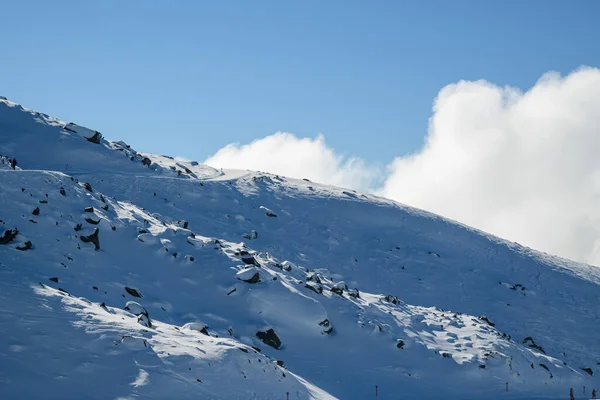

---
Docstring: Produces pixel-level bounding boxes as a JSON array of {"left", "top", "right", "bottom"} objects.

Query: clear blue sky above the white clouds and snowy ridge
[{"left": 0, "top": 0, "right": 600, "bottom": 163}]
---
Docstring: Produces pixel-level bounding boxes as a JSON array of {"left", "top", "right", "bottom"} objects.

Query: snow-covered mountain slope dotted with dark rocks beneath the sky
[{"left": 0, "top": 100, "right": 600, "bottom": 399}]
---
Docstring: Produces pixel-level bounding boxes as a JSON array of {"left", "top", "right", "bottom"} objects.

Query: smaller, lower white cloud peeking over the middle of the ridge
[{"left": 205, "top": 132, "right": 379, "bottom": 190}]
